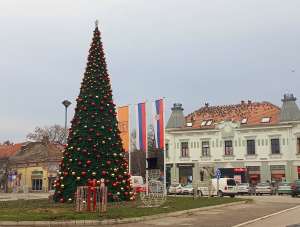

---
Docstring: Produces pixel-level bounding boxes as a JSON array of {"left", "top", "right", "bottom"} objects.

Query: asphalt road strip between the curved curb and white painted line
[{"left": 104, "top": 196, "right": 300, "bottom": 227}]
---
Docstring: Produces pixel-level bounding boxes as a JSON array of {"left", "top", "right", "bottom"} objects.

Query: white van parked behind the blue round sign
[{"left": 198, "top": 178, "right": 238, "bottom": 197}]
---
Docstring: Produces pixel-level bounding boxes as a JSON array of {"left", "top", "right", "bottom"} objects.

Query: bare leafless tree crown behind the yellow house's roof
[{"left": 26, "top": 125, "right": 65, "bottom": 144}]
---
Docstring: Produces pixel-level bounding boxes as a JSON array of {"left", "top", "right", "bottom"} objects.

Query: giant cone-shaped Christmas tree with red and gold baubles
[{"left": 54, "top": 22, "right": 132, "bottom": 202}]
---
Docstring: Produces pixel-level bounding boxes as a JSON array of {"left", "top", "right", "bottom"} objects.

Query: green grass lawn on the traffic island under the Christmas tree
[{"left": 0, "top": 197, "right": 247, "bottom": 221}]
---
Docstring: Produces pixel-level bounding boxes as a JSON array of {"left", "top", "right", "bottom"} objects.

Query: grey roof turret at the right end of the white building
[{"left": 280, "top": 94, "right": 300, "bottom": 122}]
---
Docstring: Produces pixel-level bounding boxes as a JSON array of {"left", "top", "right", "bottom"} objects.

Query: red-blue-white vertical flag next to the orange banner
[{"left": 136, "top": 102, "right": 147, "bottom": 151}]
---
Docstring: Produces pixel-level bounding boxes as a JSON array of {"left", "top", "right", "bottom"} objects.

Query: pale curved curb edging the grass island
[{"left": 0, "top": 200, "right": 248, "bottom": 227}]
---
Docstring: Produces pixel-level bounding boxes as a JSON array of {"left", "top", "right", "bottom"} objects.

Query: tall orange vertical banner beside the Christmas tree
[{"left": 117, "top": 106, "right": 130, "bottom": 152}]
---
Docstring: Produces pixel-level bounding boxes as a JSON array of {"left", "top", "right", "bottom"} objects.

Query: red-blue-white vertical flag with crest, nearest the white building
[{"left": 153, "top": 99, "right": 165, "bottom": 150}]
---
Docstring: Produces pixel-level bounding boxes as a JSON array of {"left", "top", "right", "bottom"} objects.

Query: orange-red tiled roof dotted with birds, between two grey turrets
[{"left": 185, "top": 101, "right": 280, "bottom": 128}]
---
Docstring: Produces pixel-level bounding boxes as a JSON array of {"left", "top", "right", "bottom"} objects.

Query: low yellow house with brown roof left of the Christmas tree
[{"left": 4, "top": 142, "right": 63, "bottom": 192}]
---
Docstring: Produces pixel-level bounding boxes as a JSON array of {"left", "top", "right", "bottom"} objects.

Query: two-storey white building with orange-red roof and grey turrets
[{"left": 166, "top": 94, "right": 300, "bottom": 184}]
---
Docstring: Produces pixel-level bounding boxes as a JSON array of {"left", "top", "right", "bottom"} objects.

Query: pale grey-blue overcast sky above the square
[{"left": 0, "top": 0, "right": 300, "bottom": 142}]
